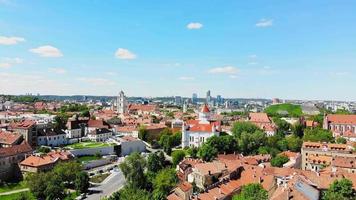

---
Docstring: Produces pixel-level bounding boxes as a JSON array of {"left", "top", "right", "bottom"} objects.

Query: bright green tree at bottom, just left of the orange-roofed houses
[{"left": 153, "top": 168, "right": 178, "bottom": 200}]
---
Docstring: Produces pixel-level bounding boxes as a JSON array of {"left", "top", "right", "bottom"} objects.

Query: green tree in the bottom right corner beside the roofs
[{"left": 323, "top": 178, "right": 356, "bottom": 200}]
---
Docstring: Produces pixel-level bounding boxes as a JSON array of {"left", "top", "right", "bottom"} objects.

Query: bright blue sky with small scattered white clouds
[{"left": 0, "top": 0, "right": 356, "bottom": 100}]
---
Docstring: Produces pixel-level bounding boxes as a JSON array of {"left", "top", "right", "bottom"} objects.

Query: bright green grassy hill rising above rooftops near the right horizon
[{"left": 265, "top": 103, "right": 303, "bottom": 117}]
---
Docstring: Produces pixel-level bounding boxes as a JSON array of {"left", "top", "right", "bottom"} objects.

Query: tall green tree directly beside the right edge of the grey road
[{"left": 120, "top": 152, "right": 147, "bottom": 189}]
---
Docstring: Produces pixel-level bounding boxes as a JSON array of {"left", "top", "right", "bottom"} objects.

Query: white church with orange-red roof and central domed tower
[{"left": 182, "top": 104, "right": 221, "bottom": 148}]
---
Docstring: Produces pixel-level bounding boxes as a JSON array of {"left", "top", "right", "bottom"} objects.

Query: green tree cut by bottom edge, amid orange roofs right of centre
[{"left": 232, "top": 183, "right": 268, "bottom": 200}]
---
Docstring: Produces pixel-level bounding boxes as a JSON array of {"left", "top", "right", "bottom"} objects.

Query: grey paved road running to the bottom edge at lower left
[{"left": 86, "top": 171, "right": 125, "bottom": 200}]
